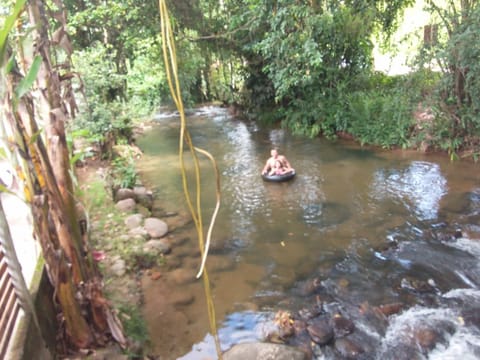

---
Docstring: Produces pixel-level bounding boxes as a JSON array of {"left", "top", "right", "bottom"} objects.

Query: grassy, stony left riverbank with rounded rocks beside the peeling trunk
[{"left": 76, "top": 140, "right": 201, "bottom": 358}]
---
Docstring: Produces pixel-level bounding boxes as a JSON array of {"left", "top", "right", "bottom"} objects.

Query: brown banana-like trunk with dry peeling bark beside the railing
[{"left": 2, "top": 0, "right": 126, "bottom": 350}]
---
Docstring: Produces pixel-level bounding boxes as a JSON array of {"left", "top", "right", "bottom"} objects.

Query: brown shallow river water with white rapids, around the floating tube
[{"left": 137, "top": 107, "right": 480, "bottom": 360}]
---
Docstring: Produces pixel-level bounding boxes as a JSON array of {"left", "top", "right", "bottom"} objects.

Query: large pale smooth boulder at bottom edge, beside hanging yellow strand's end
[{"left": 222, "top": 343, "right": 307, "bottom": 360}]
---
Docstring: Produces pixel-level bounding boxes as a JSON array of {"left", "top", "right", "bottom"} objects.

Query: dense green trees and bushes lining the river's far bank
[{"left": 60, "top": 0, "right": 480, "bottom": 154}]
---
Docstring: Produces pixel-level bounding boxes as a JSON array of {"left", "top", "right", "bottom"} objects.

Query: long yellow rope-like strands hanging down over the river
[{"left": 159, "top": 0, "right": 222, "bottom": 359}]
